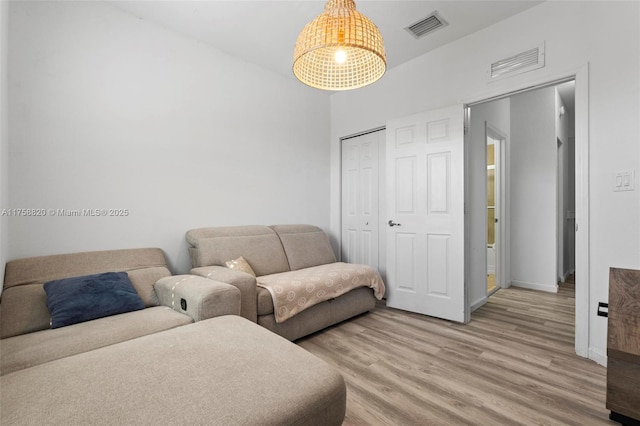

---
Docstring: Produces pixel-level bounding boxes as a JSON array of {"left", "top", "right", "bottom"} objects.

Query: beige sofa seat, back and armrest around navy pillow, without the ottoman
[{"left": 0, "top": 248, "right": 240, "bottom": 375}]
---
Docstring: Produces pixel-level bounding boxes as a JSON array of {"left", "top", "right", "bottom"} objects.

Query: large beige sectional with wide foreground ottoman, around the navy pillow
[{"left": 0, "top": 249, "right": 346, "bottom": 426}]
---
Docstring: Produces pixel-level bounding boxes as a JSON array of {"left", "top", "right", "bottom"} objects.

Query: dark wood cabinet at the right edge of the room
[{"left": 607, "top": 268, "right": 640, "bottom": 425}]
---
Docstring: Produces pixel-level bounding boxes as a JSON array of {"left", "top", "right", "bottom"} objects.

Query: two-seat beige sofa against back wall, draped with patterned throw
[{"left": 186, "top": 225, "right": 384, "bottom": 340}]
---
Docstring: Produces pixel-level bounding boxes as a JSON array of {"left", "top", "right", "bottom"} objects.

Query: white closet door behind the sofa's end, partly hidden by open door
[{"left": 342, "top": 131, "right": 384, "bottom": 269}]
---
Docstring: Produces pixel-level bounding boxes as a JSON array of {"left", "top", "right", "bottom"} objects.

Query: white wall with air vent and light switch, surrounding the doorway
[{"left": 331, "top": 1, "right": 640, "bottom": 362}]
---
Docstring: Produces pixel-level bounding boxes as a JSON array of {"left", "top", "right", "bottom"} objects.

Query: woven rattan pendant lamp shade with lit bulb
[{"left": 293, "top": 0, "right": 386, "bottom": 90}]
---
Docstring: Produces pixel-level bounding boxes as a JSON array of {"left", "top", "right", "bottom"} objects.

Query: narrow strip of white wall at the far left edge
[{"left": 0, "top": 1, "right": 9, "bottom": 293}]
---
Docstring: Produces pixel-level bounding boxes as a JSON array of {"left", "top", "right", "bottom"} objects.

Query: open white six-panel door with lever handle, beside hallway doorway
[{"left": 386, "top": 105, "right": 468, "bottom": 322}]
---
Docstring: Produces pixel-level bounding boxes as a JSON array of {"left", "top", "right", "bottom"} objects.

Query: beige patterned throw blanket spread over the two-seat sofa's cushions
[{"left": 257, "top": 262, "right": 384, "bottom": 323}]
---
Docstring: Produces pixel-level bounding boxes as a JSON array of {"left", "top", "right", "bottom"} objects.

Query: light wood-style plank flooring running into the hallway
[{"left": 297, "top": 284, "right": 617, "bottom": 426}]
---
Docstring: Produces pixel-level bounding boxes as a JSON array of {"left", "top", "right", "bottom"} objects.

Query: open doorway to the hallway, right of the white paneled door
[{"left": 466, "top": 76, "right": 588, "bottom": 346}]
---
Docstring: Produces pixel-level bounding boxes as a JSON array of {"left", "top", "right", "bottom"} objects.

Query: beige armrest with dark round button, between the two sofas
[{"left": 154, "top": 275, "right": 240, "bottom": 321}]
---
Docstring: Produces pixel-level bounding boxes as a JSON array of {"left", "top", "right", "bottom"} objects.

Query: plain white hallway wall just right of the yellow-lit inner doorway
[{"left": 508, "top": 87, "right": 558, "bottom": 292}]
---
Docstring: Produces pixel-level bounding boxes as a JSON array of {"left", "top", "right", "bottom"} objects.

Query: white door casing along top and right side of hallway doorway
[{"left": 463, "top": 63, "right": 592, "bottom": 363}]
